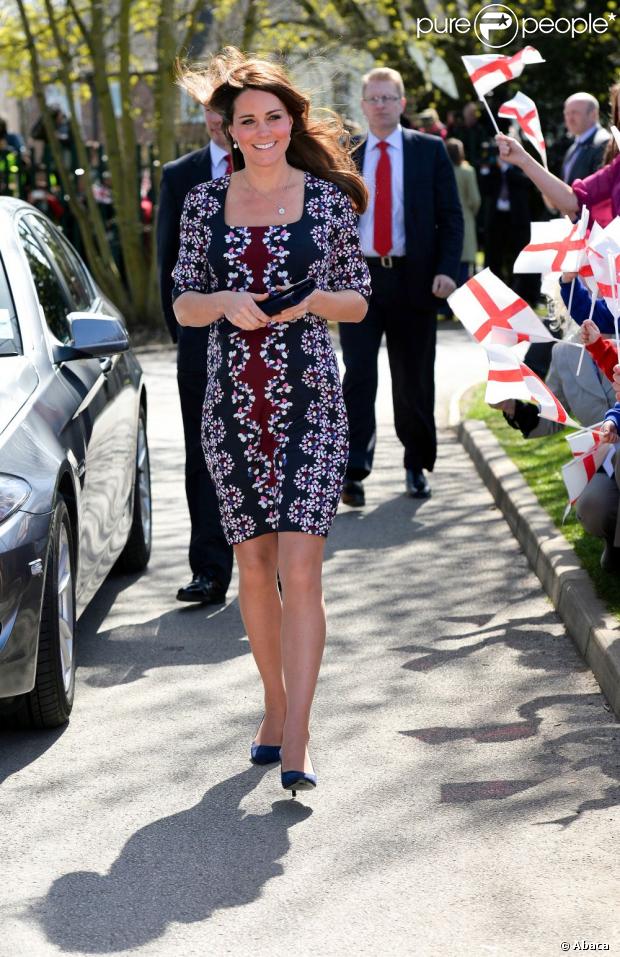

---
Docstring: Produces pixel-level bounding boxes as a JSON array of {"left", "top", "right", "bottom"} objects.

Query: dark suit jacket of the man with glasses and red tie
[{"left": 353, "top": 129, "right": 464, "bottom": 310}]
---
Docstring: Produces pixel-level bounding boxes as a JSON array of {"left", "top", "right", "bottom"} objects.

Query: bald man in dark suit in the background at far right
[{"left": 562, "top": 92, "right": 609, "bottom": 186}]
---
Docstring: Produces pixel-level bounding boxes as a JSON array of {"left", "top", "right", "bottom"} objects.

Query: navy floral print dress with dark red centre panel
[{"left": 173, "top": 173, "right": 370, "bottom": 544}]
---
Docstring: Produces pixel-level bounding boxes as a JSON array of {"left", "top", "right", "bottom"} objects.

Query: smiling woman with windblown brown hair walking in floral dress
[{"left": 173, "top": 48, "right": 370, "bottom": 795}]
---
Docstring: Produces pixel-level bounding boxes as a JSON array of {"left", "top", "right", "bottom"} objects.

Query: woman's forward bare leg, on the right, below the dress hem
[{"left": 278, "top": 532, "right": 325, "bottom": 772}]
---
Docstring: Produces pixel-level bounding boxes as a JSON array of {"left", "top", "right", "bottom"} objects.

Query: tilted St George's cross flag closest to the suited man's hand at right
[{"left": 448, "top": 268, "right": 553, "bottom": 346}]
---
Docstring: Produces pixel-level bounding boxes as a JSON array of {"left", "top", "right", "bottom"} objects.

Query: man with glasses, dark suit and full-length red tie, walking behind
[{"left": 340, "top": 68, "right": 463, "bottom": 507}]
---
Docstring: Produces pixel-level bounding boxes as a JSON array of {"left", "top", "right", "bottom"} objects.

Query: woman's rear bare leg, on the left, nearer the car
[{"left": 234, "top": 532, "right": 286, "bottom": 745}]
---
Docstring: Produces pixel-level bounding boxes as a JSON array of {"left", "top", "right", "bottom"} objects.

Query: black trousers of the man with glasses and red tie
[{"left": 340, "top": 263, "right": 437, "bottom": 480}]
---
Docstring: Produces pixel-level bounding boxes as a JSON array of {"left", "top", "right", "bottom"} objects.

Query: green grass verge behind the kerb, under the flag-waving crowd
[{"left": 461, "top": 384, "right": 620, "bottom": 619}]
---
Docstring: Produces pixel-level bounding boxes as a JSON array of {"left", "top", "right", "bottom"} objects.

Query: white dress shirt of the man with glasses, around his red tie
[{"left": 359, "top": 124, "right": 405, "bottom": 256}]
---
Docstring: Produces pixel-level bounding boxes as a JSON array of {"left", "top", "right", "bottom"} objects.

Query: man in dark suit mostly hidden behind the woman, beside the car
[{"left": 157, "top": 108, "right": 233, "bottom": 604}]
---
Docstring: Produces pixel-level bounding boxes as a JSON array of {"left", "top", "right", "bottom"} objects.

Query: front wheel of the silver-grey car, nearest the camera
[{"left": 19, "top": 499, "right": 76, "bottom": 728}]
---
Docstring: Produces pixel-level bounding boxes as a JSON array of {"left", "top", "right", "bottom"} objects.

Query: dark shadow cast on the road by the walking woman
[{"left": 31, "top": 767, "right": 312, "bottom": 954}]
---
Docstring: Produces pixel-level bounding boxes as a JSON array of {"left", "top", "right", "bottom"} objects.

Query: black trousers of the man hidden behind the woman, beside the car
[{"left": 177, "top": 369, "right": 233, "bottom": 588}]
